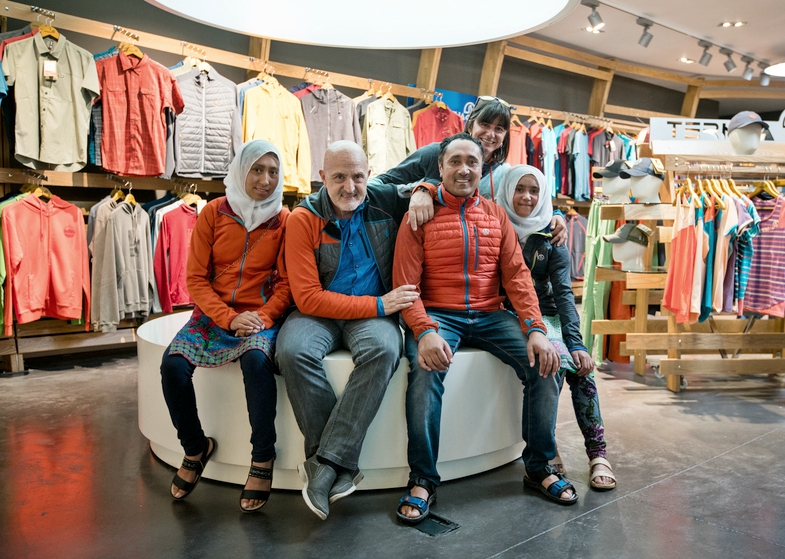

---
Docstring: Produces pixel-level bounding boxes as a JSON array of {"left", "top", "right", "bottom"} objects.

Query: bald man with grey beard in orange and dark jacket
[{"left": 276, "top": 141, "right": 418, "bottom": 520}]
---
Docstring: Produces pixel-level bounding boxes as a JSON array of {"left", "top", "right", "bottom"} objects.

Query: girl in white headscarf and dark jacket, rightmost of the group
[{"left": 496, "top": 165, "right": 616, "bottom": 491}]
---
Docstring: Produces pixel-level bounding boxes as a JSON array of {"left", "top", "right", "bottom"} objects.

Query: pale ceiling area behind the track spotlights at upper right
[{"left": 533, "top": 0, "right": 785, "bottom": 112}]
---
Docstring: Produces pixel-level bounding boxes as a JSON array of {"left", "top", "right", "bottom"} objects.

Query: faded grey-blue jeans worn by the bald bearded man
[{"left": 275, "top": 311, "right": 402, "bottom": 470}]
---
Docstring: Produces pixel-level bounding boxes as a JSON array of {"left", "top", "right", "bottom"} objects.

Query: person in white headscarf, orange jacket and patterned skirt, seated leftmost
[{"left": 161, "top": 140, "right": 292, "bottom": 512}]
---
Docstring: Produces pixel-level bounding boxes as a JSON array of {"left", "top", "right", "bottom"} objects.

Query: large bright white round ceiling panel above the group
[{"left": 147, "top": 0, "right": 578, "bottom": 49}]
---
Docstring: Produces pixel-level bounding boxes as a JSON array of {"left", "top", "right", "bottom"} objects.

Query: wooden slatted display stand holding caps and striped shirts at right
[{"left": 592, "top": 142, "right": 785, "bottom": 392}]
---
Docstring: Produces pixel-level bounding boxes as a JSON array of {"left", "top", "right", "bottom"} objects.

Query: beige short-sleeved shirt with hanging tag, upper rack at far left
[{"left": 3, "top": 33, "right": 100, "bottom": 172}]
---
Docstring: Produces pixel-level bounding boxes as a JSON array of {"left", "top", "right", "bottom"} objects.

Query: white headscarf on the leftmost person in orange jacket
[{"left": 224, "top": 140, "right": 283, "bottom": 231}]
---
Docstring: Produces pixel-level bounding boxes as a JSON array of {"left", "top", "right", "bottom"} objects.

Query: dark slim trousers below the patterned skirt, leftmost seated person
[{"left": 161, "top": 347, "right": 277, "bottom": 462}]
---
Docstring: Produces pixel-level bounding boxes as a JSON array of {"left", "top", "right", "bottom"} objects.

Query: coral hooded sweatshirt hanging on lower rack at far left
[{"left": 3, "top": 195, "right": 90, "bottom": 336}]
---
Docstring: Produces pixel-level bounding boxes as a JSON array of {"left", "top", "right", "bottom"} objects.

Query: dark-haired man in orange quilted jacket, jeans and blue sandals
[{"left": 393, "top": 133, "right": 577, "bottom": 524}]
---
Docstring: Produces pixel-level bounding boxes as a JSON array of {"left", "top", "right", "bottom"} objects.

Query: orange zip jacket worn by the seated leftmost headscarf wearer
[{"left": 187, "top": 196, "right": 292, "bottom": 330}]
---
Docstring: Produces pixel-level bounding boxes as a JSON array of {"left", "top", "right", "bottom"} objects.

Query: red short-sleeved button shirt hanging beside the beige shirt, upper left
[{"left": 96, "top": 52, "right": 185, "bottom": 177}]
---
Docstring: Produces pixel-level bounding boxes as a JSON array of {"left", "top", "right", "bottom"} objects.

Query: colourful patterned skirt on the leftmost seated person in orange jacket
[{"left": 169, "top": 309, "right": 283, "bottom": 368}]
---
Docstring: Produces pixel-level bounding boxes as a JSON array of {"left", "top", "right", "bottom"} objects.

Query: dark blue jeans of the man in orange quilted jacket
[{"left": 405, "top": 308, "right": 560, "bottom": 485}]
